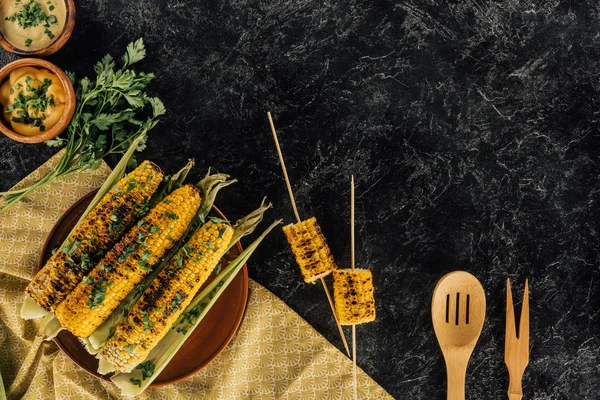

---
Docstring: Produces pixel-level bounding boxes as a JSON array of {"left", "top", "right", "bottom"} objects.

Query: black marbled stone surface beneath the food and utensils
[{"left": 0, "top": 0, "right": 600, "bottom": 399}]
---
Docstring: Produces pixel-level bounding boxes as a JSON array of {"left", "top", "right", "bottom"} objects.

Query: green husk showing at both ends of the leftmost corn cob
[{"left": 21, "top": 135, "right": 146, "bottom": 324}]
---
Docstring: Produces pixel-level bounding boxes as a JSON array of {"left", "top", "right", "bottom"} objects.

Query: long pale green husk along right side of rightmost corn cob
[{"left": 111, "top": 220, "right": 282, "bottom": 397}]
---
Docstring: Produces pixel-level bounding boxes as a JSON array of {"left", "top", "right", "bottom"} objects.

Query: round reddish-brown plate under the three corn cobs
[{"left": 39, "top": 191, "right": 248, "bottom": 386}]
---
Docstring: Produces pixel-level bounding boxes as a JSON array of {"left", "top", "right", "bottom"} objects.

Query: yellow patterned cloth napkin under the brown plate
[{"left": 0, "top": 153, "right": 392, "bottom": 400}]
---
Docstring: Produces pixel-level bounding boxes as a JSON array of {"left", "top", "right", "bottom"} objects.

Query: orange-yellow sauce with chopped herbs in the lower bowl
[{"left": 0, "top": 67, "right": 66, "bottom": 136}]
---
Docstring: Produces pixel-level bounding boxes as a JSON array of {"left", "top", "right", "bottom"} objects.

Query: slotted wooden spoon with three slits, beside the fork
[{"left": 431, "top": 271, "right": 485, "bottom": 400}]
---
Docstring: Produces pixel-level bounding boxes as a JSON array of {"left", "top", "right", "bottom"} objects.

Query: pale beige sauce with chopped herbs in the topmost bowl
[{"left": 0, "top": 0, "right": 67, "bottom": 50}]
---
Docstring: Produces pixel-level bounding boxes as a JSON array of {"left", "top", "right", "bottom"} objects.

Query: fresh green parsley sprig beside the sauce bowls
[{"left": 0, "top": 39, "right": 165, "bottom": 210}]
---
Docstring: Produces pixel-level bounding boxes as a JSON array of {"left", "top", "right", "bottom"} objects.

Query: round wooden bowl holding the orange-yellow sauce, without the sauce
[{"left": 0, "top": 58, "right": 77, "bottom": 143}]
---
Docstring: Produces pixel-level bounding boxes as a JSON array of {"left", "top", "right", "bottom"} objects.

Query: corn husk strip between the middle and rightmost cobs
[{"left": 81, "top": 170, "right": 236, "bottom": 352}]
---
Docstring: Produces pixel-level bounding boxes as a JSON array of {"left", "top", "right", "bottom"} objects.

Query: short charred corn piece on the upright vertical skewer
[{"left": 333, "top": 269, "right": 375, "bottom": 325}]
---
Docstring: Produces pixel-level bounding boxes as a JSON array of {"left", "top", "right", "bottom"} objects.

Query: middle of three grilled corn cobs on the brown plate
[{"left": 56, "top": 185, "right": 200, "bottom": 337}]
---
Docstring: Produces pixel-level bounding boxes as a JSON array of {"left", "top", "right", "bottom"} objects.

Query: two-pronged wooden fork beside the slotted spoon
[{"left": 504, "top": 279, "right": 529, "bottom": 400}]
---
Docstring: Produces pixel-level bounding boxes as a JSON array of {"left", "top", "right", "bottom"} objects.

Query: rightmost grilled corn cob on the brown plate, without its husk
[{"left": 100, "top": 221, "right": 233, "bottom": 372}]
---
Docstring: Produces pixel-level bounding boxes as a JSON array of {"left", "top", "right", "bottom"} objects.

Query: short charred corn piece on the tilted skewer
[{"left": 283, "top": 217, "right": 337, "bottom": 283}]
